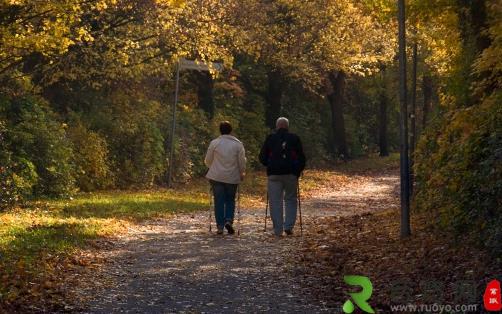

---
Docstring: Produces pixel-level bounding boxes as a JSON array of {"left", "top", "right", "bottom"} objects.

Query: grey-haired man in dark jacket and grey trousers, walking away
[{"left": 260, "top": 117, "right": 305, "bottom": 236}]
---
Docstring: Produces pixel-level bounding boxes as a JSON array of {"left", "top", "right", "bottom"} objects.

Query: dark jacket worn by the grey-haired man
[{"left": 260, "top": 129, "right": 305, "bottom": 177}]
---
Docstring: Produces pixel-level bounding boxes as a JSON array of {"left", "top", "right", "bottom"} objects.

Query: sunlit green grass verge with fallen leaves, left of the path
[{"left": 0, "top": 188, "right": 208, "bottom": 312}]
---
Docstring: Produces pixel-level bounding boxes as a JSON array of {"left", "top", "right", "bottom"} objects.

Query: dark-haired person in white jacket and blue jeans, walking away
[{"left": 204, "top": 121, "right": 246, "bottom": 234}]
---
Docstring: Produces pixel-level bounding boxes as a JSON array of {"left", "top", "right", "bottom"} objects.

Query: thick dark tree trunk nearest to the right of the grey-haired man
[{"left": 328, "top": 71, "right": 349, "bottom": 160}]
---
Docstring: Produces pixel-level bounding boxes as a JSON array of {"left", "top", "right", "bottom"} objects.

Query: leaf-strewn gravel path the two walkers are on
[{"left": 71, "top": 170, "right": 398, "bottom": 313}]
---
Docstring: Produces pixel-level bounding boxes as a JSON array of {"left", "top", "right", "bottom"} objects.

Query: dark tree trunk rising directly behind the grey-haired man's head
[{"left": 265, "top": 70, "right": 284, "bottom": 129}]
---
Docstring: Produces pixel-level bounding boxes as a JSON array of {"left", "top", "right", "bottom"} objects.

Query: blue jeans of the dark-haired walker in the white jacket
[{"left": 209, "top": 180, "right": 237, "bottom": 229}]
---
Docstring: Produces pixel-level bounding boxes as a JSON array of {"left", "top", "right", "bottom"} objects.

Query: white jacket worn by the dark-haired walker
[{"left": 204, "top": 134, "right": 246, "bottom": 184}]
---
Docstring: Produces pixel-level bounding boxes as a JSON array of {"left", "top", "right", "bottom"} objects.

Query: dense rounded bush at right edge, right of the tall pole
[{"left": 415, "top": 92, "right": 502, "bottom": 254}]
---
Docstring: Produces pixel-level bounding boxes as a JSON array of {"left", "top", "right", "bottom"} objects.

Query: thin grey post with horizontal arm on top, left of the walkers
[{"left": 167, "top": 58, "right": 223, "bottom": 188}]
